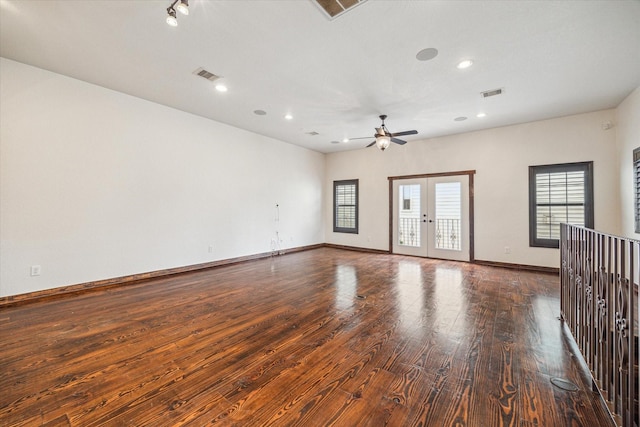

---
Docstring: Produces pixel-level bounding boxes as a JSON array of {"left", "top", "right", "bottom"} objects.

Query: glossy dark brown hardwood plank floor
[{"left": 0, "top": 248, "right": 614, "bottom": 427}]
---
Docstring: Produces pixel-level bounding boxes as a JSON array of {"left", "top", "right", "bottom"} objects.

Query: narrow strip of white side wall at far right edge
[{"left": 615, "top": 87, "right": 640, "bottom": 239}]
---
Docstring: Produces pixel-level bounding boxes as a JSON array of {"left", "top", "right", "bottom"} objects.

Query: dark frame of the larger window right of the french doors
[{"left": 529, "top": 162, "right": 594, "bottom": 248}]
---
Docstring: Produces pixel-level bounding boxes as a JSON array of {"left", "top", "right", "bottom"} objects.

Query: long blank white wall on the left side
[{"left": 0, "top": 59, "right": 324, "bottom": 296}]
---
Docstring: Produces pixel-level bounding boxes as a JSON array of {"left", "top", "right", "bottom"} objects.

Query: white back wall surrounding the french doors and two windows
[{"left": 325, "top": 110, "right": 620, "bottom": 267}]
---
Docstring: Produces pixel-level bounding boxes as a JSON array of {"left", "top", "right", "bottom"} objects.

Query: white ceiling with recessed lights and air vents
[{"left": 0, "top": 0, "right": 640, "bottom": 153}]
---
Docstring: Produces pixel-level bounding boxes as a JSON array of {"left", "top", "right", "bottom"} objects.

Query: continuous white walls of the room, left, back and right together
[{"left": 0, "top": 58, "right": 640, "bottom": 296}]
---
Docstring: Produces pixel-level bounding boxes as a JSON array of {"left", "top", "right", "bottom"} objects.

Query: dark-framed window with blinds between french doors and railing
[{"left": 529, "top": 162, "right": 593, "bottom": 248}]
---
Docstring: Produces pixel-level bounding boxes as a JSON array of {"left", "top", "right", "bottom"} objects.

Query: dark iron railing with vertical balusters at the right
[{"left": 560, "top": 224, "right": 640, "bottom": 427}]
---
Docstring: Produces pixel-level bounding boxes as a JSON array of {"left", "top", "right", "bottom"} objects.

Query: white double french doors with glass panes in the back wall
[{"left": 392, "top": 175, "right": 470, "bottom": 261}]
